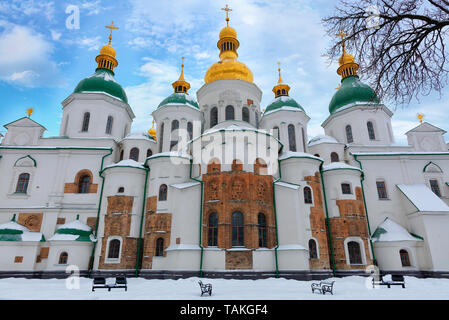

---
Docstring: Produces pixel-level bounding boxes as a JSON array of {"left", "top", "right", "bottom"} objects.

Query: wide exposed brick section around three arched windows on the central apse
[{"left": 202, "top": 169, "right": 276, "bottom": 249}]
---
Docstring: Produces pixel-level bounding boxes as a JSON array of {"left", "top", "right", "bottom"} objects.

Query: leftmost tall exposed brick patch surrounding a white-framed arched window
[{"left": 99, "top": 196, "right": 138, "bottom": 269}]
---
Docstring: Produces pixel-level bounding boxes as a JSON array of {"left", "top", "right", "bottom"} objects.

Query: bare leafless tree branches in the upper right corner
[{"left": 323, "top": 0, "right": 449, "bottom": 105}]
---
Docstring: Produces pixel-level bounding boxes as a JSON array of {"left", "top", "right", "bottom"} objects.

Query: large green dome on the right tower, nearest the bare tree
[{"left": 329, "top": 76, "right": 380, "bottom": 114}]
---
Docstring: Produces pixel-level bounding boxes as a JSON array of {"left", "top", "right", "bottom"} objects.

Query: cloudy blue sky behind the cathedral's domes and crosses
[{"left": 0, "top": 0, "right": 449, "bottom": 144}]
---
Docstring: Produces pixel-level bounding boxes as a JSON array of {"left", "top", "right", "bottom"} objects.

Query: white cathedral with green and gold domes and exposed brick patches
[{"left": 0, "top": 12, "right": 449, "bottom": 279}]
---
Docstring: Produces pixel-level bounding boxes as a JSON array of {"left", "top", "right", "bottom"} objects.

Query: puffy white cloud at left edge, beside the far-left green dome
[{"left": 0, "top": 24, "right": 61, "bottom": 87}]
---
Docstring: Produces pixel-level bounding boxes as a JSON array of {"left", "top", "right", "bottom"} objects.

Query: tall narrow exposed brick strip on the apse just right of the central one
[{"left": 304, "top": 172, "right": 331, "bottom": 270}]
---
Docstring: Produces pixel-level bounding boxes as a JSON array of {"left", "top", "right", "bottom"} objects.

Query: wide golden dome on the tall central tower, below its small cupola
[{"left": 204, "top": 60, "right": 253, "bottom": 83}]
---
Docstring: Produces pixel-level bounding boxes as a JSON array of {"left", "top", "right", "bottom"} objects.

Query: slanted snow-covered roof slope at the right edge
[{"left": 397, "top": 184, "right": 449, "bottom": 212}]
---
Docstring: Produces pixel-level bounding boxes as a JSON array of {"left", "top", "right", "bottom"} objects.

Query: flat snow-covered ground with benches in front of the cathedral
[{"left": 0, "top": 276, "right": 449, "bottom": 300}]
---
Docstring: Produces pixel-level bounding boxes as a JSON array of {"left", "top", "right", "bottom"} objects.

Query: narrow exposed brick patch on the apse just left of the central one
[{"left": 142, "top": 212, "right": 172, "bottom": 269}]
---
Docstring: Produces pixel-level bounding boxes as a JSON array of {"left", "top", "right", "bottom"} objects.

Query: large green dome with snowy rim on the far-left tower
[{"left": 73, "top": 68, "right": 128, "bottom": 103}]
